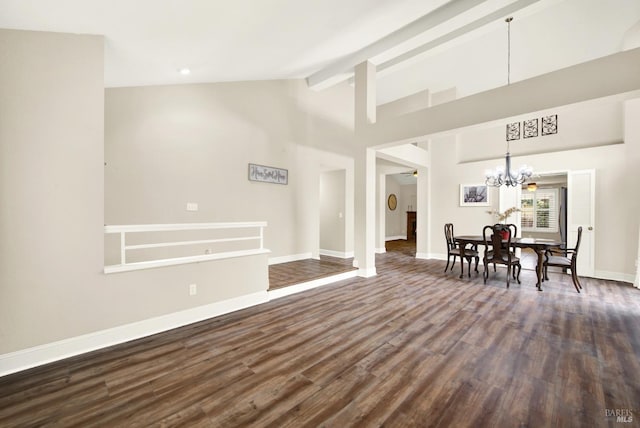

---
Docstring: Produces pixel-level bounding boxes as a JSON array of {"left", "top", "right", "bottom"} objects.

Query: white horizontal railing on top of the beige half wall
[{"left": 104, "top": 221, "right": 269, "bottom": 273}]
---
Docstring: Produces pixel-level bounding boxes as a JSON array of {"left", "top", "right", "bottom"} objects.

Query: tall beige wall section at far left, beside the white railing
[{"left": 0, "top": 30, "right": 106, "bottom": 354}]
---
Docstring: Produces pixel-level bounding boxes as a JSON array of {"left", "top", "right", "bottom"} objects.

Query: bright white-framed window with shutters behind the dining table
[{"left": 520, "top": 189, "right": 558, "bottom": 233}]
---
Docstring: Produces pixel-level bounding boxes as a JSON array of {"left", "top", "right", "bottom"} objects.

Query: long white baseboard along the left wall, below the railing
[{"left": 0, "top": 291, "right": 269, "bottom": 377}]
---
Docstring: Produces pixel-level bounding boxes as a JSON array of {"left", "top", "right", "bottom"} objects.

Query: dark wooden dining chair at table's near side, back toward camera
[{"left": 482, "top": 224, "right": 522, "bottom": 288}]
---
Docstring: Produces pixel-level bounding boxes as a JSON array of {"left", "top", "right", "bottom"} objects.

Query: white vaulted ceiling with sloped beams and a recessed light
[{"left": 0, "top": 0, "right": 640, "bottom": 103}]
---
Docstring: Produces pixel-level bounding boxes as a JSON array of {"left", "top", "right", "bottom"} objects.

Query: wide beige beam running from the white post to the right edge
[{"left": 359, "top": 48, "right": 640, "bottom": 147}]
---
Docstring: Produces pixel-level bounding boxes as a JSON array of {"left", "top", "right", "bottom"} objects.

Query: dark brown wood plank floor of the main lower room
[{"left": 0, "top": 244, "right": 640, "bottom": 427}]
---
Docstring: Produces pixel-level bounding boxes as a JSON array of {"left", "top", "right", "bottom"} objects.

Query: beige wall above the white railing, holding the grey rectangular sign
[{"left": 105, "top": 81, "right": 352, "bottom": 258}]
